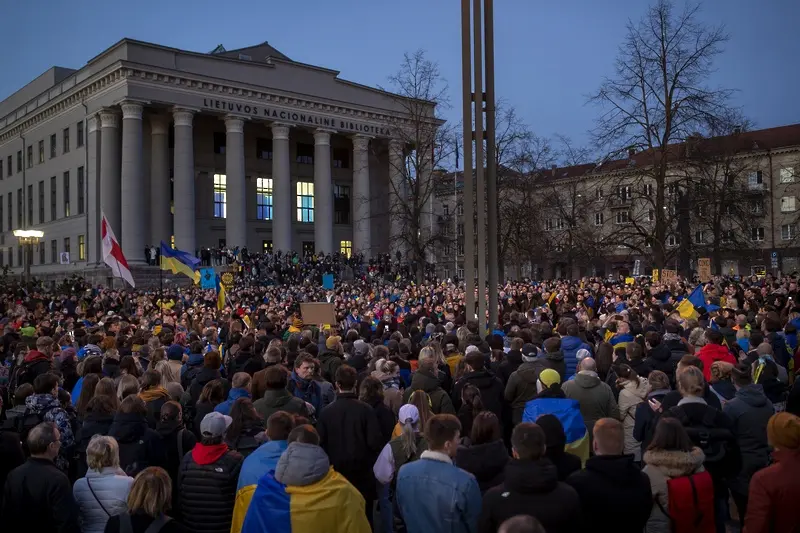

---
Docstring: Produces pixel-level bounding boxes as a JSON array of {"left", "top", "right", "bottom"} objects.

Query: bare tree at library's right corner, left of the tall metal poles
[{"left": 382, "top": 50, "right": 456, "bottom": 281}]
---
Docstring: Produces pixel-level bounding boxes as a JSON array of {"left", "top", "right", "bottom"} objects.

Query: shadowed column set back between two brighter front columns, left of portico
[{"left": 150, "top": 114, "right": 170, "bottom": 245}]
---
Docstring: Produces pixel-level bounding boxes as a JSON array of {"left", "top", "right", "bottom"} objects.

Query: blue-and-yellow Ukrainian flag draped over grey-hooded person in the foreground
[{"left": 238, "top": 467, "right": 371, "bottom": 533}]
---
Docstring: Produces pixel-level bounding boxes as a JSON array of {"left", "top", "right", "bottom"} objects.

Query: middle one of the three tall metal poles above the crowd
[{"left": 472, "top": 0, "right": 486, "bottom": 328}]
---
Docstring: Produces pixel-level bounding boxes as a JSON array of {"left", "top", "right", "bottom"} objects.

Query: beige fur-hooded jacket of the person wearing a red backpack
[{"left": 642, "top": 447, "right": 706, "bottom": 533}]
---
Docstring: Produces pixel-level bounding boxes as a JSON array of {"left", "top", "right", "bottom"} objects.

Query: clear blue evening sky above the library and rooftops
[{"left": 0, "top": 0, "right": 800, "bottom": 153}]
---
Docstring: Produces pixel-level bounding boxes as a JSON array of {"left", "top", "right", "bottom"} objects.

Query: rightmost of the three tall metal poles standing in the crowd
[{"left": 483, "top": 0, "right": 500, "bottom": 329}]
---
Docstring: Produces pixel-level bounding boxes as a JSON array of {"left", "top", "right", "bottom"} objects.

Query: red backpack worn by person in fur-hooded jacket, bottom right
[{"left": 656, "top": 471, "right": 715, "bottom": 533}]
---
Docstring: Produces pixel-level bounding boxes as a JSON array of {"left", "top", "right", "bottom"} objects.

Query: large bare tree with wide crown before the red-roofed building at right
[{"left": 590, "top": 0, "right": 731, "bottom": 268}]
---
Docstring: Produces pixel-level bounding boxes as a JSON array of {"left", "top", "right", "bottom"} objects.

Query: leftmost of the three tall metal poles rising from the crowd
[{"left": 456, "top": 0, "right": 480, "bottom": 319}]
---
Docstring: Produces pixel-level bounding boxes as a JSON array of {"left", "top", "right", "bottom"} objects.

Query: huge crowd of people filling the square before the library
[{"left": 0, "top": 272, "right": 800, "bottom": 533}]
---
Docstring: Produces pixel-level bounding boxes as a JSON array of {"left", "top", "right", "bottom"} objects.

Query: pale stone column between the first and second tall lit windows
[{"left": 225, "top": 115, "right": 247, "bottom": 248}]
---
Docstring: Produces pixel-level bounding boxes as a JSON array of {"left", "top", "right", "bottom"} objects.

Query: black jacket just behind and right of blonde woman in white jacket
[{"left": 108, "top": 413, "right": 166, "bottom": 477}]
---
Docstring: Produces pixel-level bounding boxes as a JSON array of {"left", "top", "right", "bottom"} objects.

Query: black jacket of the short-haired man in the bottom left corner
[{"left": 0, "top": 457, "right": 81, "bottom": 533}]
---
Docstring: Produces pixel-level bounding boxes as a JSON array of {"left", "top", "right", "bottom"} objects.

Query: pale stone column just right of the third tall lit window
[{"left": 314, "top": 129, "right": 334, "bottom": 254}]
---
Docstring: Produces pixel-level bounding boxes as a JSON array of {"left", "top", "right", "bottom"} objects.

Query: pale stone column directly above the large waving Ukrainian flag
[{"left": 172, "top": 109, "right": 195, "bottom": 254}]
